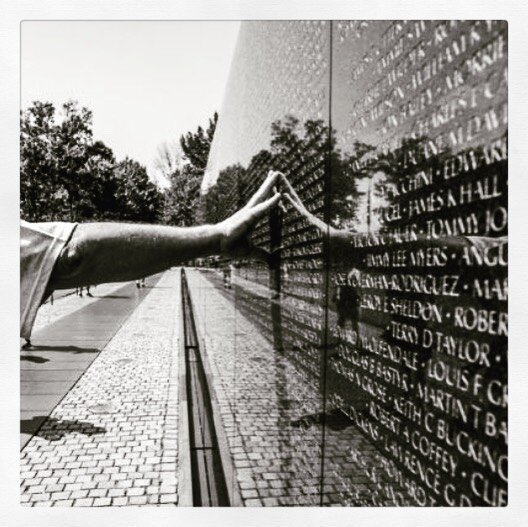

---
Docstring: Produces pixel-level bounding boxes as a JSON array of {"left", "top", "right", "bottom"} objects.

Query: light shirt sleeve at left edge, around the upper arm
[{"left": 20, "top": 221, "right": 77, "bottom": 338}]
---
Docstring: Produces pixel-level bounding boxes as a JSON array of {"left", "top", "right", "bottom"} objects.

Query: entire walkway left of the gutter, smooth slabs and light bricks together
[{"left": 21, "top": 270, "right": 184, "bottom": 506}]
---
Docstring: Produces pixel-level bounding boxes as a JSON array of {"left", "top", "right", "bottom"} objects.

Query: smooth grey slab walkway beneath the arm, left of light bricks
[{"left": 20, "top": 276, "right": 159, "bottom": 449}]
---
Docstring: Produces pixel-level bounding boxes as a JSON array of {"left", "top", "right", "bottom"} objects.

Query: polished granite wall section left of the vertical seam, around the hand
[{"left": 199, "top": 21, "right": 330, "bottom": 505}]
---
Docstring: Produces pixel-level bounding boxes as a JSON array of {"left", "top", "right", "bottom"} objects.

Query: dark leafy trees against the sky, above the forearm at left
[{"left": 20, "top": 101, "right": 162, "bottom": 222}]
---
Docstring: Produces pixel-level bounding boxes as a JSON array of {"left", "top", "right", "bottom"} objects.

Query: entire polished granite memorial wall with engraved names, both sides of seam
[{"left": 198, "top": 21, "right": 508, "bottom": 506}]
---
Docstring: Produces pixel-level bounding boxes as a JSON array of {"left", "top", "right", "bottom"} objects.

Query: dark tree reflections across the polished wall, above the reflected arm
[{"left": 204, "top": 116, "right": 505, "bottom": 245}]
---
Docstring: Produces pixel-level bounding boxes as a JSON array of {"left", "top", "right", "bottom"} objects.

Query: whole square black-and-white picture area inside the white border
[{"left": 2, "top": 1, "right": 525, "bottom": 526}]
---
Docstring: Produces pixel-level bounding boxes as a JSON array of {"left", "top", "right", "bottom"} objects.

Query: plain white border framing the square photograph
[{"left": 0, "top": 0, "right": 528, "bottom": 527}]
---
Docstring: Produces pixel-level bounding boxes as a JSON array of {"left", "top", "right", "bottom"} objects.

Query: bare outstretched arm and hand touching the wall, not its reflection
[{"left": 48, "top": 173, "right": 280, "bottom": 292}]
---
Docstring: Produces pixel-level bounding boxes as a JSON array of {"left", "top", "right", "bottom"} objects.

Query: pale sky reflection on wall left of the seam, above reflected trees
[{"left": 202, "top": 21, "right": 329, "bottom": 191}]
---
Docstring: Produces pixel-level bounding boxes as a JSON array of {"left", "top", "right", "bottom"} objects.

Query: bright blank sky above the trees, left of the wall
[{"left": 21, "top": 21, "right": 240, "bottom": 186}]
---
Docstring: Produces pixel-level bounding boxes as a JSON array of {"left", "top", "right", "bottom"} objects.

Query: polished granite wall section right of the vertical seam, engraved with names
[{"left": 325, "top": 21, "right": 508, "bottom": 505}]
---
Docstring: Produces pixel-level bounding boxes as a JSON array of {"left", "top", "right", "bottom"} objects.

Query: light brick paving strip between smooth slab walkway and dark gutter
[{"left": 21, "top": 270, "right": 180, "bottom": 507}]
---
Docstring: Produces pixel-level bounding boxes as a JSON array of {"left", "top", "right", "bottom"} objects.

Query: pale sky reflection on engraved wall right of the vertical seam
[{"left": 332, "top": 21, "right": 508, "bottom": 159}]
